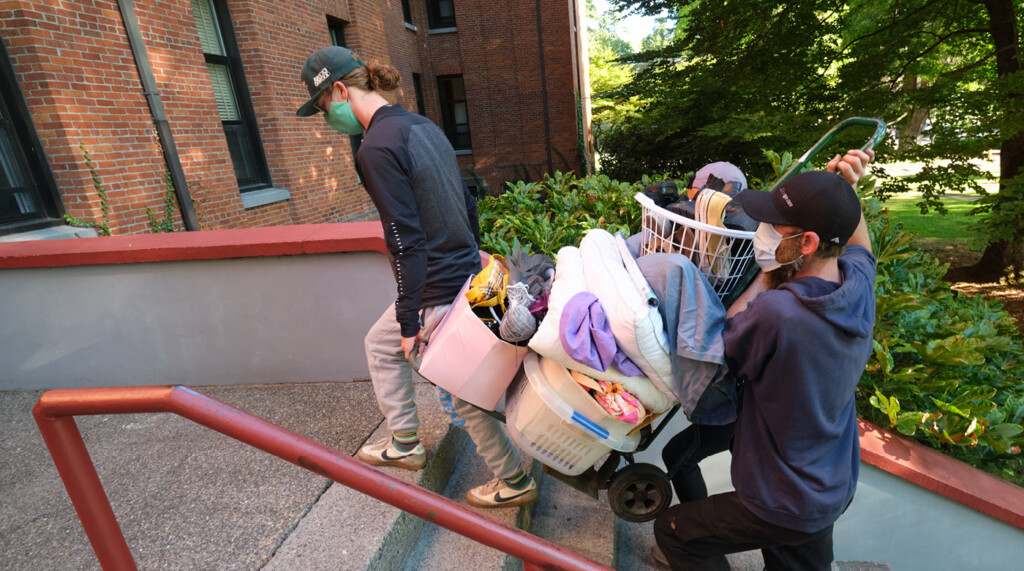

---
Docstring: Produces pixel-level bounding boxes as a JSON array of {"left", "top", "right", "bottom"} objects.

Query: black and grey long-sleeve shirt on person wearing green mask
[{"left": 356, "top": 105, "right": 480, "bottom": 337}]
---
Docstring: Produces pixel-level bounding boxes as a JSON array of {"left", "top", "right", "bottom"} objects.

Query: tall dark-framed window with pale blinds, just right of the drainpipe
[{"left": 191, "top": 0, "right": 270, "bottom": 192}]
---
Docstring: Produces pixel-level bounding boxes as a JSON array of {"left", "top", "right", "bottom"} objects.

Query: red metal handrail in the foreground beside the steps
[{"left": 32, "top": 386, "right": 609, "bottom": 570}]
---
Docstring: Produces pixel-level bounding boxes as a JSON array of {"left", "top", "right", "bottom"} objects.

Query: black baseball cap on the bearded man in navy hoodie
[{"left": 737, "top": 171, "right": 860, "bottom": 246}]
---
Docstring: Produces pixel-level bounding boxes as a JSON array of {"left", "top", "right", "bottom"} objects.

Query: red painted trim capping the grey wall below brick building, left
[{"left": 0, "top": 222, "right": 386, "bottom": 269}]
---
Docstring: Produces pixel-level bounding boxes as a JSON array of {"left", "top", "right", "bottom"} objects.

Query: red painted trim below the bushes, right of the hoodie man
[{"left": 858, "top": 420, "right": 1024, "bottom": 529}]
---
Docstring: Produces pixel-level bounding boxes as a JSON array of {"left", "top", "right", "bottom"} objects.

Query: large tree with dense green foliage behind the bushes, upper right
[{"left": 603, "top": 0, "right": 1024, "bottom": 281}]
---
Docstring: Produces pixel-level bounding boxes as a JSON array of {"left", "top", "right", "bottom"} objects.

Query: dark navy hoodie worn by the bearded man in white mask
[{"left": 723, "top": 246, "right": 876, "bottom": 532}]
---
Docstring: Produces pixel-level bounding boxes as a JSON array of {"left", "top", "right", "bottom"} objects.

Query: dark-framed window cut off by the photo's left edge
[{"left": 0, "top": 39, "right": 63, "bottom": 234}]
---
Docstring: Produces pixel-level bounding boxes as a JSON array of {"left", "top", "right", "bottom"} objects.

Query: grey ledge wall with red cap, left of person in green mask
[{"left": 0, "top": 222, "right": 395, "bottom": 390}]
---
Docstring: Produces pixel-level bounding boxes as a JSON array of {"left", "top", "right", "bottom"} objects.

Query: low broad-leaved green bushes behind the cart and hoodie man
[{"left": 480, "top": 162, "right": 1024, "bottom": 485}]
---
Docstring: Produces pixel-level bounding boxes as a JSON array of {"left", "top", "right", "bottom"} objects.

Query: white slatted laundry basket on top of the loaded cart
[{"left": 636, "top": 192, "right": 754, "bottom": 300}]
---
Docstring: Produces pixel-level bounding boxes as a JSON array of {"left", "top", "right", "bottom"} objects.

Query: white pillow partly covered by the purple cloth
[{"left": 528, "top": 246, "right": 675, "bottom": 412}]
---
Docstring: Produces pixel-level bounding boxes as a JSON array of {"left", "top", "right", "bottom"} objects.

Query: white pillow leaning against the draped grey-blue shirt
[{"left": 580, "top": 228, "right": 675, "bottom": 398}]
